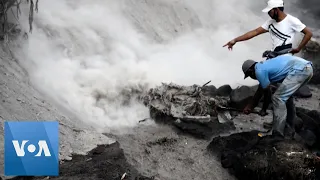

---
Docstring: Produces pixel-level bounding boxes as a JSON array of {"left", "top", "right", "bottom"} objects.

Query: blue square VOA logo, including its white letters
[{"left": 4, "top": 121, "right": 59, "bottom": 176}]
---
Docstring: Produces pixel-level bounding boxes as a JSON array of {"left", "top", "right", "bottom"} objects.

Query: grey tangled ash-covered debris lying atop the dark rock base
[{"left": 144, "top": 83, "right": 228, "bottom": 119}]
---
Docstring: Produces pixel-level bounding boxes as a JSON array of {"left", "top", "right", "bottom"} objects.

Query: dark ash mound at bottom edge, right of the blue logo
[{"left": 9, "top": 142, "right": 152, "bottom": 180}]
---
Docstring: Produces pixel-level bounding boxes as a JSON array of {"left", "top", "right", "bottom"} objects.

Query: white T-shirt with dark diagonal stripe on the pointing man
[{"left": 261, "top": 14, "right": 306, "bottom": 50}]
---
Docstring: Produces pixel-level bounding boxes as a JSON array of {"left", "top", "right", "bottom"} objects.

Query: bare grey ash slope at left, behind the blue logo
[{"left": 0, "top": 42, "right": 115, "bottom": 177}]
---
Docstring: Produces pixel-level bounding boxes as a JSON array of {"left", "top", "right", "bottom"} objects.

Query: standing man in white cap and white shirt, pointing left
[{"left": 223, "top": 0, "right": 312, "bottom": 54}]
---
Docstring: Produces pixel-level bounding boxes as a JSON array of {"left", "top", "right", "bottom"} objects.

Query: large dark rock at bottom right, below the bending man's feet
[{"left": 207, "top": 131, "right": 320, "bottom": 180}]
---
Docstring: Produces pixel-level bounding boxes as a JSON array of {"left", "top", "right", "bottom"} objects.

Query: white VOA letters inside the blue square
[{"left": 12, "top": 140, "right": 51, "bottom": 157}]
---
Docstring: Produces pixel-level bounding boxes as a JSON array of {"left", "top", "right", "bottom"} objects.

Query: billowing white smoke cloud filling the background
[{"left": 11, "top": 0, "right": 278, "bottom": 131}]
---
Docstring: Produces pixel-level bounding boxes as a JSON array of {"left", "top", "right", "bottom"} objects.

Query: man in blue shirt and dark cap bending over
[{"left": 242, "top": 55, "right": 313, "bottom": 136}]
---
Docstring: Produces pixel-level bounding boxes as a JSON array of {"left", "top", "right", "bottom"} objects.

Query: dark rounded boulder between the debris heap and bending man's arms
[{"left": 230, "top": 86, "right": 258, "bottom": 109}]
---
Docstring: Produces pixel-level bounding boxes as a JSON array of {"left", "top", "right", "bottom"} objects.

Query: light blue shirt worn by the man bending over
[{"left": 255, "top": 55, "right": 312, "bottom": 89}]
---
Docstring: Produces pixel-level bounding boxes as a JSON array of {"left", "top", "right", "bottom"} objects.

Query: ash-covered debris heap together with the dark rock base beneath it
[{"left": 143, "top": 83, "right": 234, "bottom": 138}]
